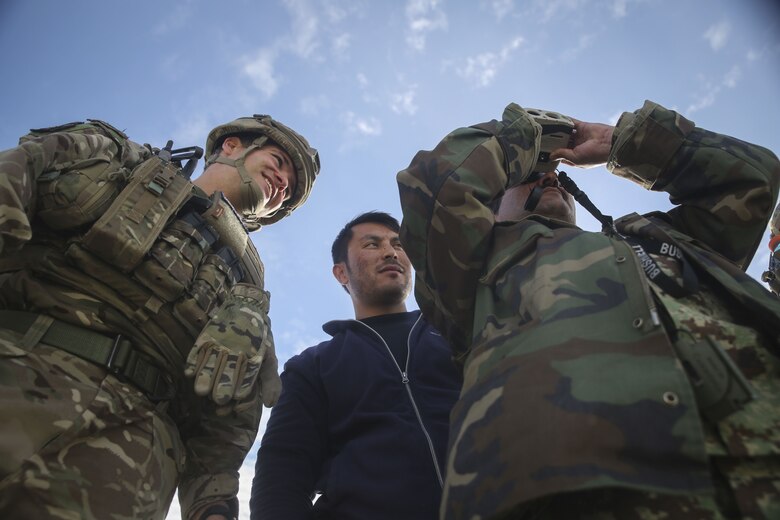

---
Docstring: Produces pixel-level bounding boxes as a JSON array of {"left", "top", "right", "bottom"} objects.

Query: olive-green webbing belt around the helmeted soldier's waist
[{"left": 0, "top": 310, "right": 175, "bottom": 401}]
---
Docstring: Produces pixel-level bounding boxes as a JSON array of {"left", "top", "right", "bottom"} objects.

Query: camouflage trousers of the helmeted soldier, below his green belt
[{"left": 0, "top": 329, "right": 184, "bottom": 520}]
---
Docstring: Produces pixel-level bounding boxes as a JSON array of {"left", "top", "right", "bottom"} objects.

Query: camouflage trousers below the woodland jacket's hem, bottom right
[{"left": 491, "top": 456, "right": 780, "bottom": 520}]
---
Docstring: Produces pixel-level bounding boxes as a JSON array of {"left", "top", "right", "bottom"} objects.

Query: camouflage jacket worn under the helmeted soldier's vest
[{"left": 0, "top": 121, "right": 262, "bottom": 517}]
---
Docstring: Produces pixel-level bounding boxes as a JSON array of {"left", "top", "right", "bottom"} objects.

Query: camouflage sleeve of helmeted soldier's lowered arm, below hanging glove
[{"left": 179, "top": 387, "right": 263, "bottom": 519}]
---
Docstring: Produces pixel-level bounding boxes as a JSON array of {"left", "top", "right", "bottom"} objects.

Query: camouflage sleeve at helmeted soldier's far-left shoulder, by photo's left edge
[{"left": 0, "top": 132, "right": 118, "bottom": 254}]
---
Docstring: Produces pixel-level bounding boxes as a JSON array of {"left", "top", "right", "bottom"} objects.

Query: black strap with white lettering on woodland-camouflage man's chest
[{"left": 624, "top": 236, "right": 699, "bottom": 298}]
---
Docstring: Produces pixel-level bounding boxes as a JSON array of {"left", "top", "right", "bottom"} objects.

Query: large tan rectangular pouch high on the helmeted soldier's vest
[{"left": 82, "top": 156, "right": 192, "bottom": 273}]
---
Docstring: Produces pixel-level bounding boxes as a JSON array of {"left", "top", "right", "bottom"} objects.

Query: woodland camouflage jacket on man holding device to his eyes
[{"left": 398, "top": 102, "right": 780, "bottom": 518}]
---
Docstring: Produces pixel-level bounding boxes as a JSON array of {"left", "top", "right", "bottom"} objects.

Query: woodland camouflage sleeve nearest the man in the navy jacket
[{"left": 397, "top": 103, "right": 541, "bottom": 353}]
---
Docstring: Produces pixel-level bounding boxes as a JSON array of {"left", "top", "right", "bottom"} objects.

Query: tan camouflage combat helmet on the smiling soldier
[{"left": 206, "top": 114, "right": 320, "bottom": 231}]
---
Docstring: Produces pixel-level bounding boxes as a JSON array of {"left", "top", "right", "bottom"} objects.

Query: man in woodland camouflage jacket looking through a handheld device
[{"left": 398, "top": 102, "right": 780, "bottom": 519}]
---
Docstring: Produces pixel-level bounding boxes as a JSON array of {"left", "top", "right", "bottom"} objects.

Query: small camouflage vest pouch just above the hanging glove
[{"left": 173, "top": 247, "right": 243, "bottom": 336}]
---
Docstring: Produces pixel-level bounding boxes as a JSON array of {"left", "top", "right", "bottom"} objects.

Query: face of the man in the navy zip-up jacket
[{"left": 333, "top": 222, "right": 412, "bottom": 318}]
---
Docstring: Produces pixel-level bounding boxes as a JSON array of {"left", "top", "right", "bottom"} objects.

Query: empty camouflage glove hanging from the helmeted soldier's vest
[{"left": 184, "top": 284, "right": 282, "bottom": 406}]
